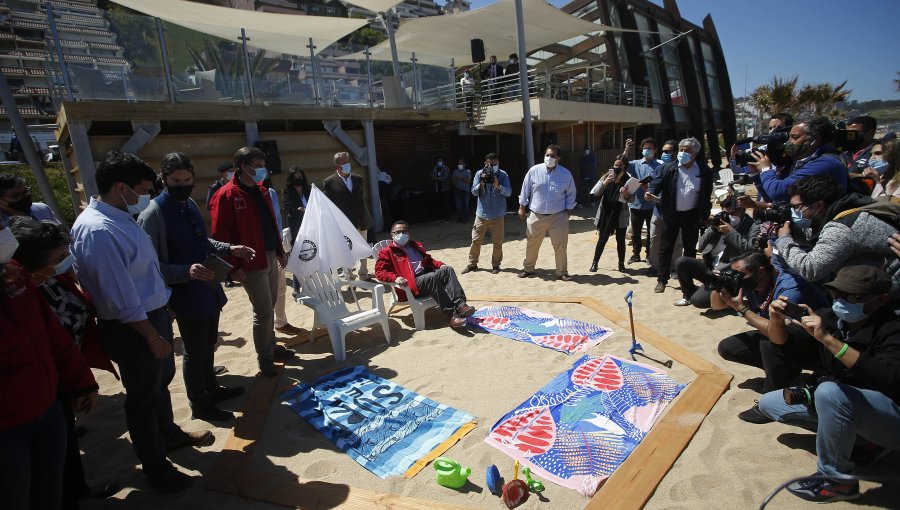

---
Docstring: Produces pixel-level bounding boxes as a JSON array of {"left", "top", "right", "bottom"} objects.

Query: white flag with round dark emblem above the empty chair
[{"left": 286, "top": 186, "right": 372, "bottom": 276}]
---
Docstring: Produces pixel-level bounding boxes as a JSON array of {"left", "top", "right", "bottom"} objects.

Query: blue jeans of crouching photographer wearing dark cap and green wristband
[{"left": 759, "top": 381, "right": 900, "bottom": 476}]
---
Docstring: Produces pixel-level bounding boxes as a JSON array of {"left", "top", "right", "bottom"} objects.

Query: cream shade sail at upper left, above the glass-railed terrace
[{"left": 113, "top": 0, "right": 370, "bottom": 55}]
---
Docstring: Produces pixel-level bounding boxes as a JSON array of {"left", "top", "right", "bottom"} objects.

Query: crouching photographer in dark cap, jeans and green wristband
[{"left": 759, "top": 266, "right": 900, "bottom": 503}]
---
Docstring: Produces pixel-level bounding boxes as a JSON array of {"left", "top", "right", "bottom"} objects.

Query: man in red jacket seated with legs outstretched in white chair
[{"left": 375, "top": 221, "right": 475, "bottom": 328}]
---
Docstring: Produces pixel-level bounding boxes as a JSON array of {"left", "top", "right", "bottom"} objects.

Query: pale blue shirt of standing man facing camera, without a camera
[{"left": 519, "top": 163, "right": 575, "bottom": 214}]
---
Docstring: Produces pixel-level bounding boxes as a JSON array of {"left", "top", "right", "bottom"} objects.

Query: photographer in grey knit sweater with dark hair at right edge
[{"left": 775, "top": 175, "right": 900, "bottom": 282}]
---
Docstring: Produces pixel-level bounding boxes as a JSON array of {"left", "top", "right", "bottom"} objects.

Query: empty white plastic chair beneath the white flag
[{"left": 295, "top": 272, "right": 391, "bottom": 362}]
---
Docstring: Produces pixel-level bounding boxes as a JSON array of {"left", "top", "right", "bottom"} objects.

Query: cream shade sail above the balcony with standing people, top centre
[{"left": 346, "top": 0, "right": 630, "bottom": 66}]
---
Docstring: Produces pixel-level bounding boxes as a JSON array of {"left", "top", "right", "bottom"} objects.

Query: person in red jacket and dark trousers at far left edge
[{"left": 0, "top": 225, "right": 98, "bottom": 508}]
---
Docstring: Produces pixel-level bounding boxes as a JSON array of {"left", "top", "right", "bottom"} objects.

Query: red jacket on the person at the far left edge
[{"left": 0, "top": 262, "right": 97, "bottom": 430}]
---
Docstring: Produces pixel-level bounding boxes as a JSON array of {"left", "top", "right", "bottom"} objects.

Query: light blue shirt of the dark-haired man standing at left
[{"left": 71, "top": 198, "right": 170, "bottom": 322}]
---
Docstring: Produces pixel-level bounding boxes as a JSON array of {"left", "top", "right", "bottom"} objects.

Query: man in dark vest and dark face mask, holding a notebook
[{"left": 137, "top": 152, "right": 255, "bottom": 421}]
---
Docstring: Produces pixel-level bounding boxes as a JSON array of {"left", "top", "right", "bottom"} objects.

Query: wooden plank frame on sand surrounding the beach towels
[{"left": 206, "top": 296, "right": 734, "bottom": 510}]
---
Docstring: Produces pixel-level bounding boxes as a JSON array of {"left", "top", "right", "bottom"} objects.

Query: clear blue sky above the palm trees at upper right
[{"left": 472, "top": 0, "right": 900, "bottom": 101}]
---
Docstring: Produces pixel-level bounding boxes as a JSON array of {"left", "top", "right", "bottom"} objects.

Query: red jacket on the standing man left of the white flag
[{"left": 209, "top": 175, "right": 284, "bottom": 271}]
